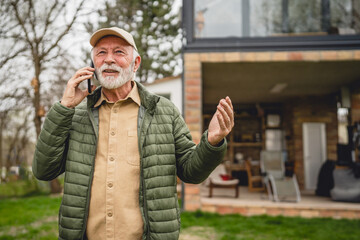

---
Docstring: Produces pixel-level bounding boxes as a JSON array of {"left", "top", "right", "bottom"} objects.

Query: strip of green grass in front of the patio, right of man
[{"left": 182, "top": 212, "right": 360, "bottom": 240}]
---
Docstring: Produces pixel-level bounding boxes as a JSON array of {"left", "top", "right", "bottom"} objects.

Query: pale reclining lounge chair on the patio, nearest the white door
[{"left": 260, "top": 151, "right": 301, "bottom": 202}]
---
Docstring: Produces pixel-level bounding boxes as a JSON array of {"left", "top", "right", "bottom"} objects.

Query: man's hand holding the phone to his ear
[{"left": 61, "top": 67, "right": 96, "bottom": 108}]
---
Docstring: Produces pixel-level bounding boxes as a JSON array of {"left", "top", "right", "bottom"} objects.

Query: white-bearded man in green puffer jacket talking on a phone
[{"left": 33, "top": 27, "right": 234, "bottom": 240}]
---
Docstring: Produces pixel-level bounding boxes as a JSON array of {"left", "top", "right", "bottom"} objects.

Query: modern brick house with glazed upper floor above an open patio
[{"left": 182, "top": 0, "right": 360, "bottom": 210}]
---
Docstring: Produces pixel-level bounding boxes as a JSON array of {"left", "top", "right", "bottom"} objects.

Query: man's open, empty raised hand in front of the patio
[{"left": 208, "top": 97, "right": 234, "bottom": 146}]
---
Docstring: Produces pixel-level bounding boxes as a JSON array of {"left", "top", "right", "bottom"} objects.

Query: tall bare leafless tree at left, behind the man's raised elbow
[{"left": 9, "top": 0, "right": 85, "bottom": 136}]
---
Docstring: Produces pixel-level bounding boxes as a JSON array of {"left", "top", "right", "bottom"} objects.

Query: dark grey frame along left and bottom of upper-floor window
[{"left": 182, "top": 0, "right": 360, "bottom": 52}]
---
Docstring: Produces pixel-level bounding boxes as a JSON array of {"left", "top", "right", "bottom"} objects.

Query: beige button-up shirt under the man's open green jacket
[{"left": 86, "top": 82, "right": 143, "bottom": 240}]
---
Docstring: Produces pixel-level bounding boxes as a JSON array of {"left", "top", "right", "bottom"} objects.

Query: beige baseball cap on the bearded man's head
[{"left": 90, "top": 27, "right": 138, "bottom": 51}]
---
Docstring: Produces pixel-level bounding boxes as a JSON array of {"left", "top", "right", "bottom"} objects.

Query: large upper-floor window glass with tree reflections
[{"left": 194, "top": 0, "right": 360, "bottom": 38}]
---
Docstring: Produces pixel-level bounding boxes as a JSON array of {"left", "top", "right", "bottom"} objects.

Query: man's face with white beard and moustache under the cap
[{"left": 93, "top": 36, "right": 137, "bottom": 89}]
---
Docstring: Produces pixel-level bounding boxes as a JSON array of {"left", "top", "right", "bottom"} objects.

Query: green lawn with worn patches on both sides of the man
[{"left": 0, "top": 196, "right": 360, "bottom": 240}]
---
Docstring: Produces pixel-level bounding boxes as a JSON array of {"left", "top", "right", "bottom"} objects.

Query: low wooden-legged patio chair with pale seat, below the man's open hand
[{"left": 208, "top": 164, "right": 239, "bottom": 198}]
